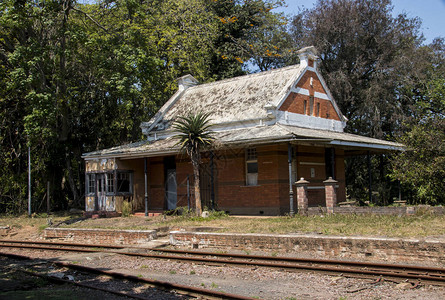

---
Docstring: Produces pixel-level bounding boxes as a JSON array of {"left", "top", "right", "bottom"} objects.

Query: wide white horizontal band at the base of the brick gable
[{"left": 277, "top": 111, "right": 344, "bottom": 132}]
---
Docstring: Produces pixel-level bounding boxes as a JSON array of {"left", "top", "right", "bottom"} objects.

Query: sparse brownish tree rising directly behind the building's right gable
[{"left": 291, "top": 0, "right": 427, "bottom": 203}]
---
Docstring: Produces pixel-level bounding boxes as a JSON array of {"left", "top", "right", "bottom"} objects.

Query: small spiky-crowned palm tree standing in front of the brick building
[{"left": 173, "top": 112, "right": 214, "bottom": 216}]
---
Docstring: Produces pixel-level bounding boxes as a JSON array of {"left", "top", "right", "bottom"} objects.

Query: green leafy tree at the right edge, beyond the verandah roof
[{"left": 391, "top": 39, "right": 445, "bottom": 204}]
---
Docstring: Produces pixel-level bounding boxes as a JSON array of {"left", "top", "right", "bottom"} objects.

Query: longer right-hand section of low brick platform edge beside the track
[{"left": 170, "top": 231, "right": 445, "bottom": 263}]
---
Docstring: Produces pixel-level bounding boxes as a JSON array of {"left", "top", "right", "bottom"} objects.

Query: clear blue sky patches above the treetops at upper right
[{"left": 278, "top": 0, "right": 445, "bottom": 44}]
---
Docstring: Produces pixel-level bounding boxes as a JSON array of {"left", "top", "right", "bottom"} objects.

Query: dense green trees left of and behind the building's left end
[{"left": 0, "top": 0, "right": 280, "bottom": 213}]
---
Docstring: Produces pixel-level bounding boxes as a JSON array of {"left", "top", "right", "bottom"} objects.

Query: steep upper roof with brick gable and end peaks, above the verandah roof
[{"left": 141, "top": 46, "right": 346, "bottom": 139}]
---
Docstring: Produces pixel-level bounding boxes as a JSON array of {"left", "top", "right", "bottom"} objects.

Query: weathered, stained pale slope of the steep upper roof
[{"left": 163, "top": 65, "right": 304, "bottom": 124}]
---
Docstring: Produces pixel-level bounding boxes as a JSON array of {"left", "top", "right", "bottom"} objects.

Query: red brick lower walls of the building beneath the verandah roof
[{"left": 119, "top": 143, "right": 345, "bottom": 215}]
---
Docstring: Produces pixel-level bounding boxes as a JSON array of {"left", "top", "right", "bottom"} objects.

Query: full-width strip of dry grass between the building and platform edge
[{"left": 0, "top": 214, "right": 445, "bottom": 238}]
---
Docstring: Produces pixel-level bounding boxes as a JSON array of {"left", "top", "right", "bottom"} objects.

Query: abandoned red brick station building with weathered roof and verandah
[{"left": 83, "top": 47, "right": 401, "bottom": 215}]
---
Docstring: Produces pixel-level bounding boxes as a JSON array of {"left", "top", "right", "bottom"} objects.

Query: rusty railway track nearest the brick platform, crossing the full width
[{"left": 0, "top": 240, "right": 445, "bottom": 285}]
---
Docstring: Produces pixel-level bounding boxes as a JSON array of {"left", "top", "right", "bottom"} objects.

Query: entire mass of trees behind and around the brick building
[{"left": 0, "top": 0, "right": 445, "bottom": 212}]
